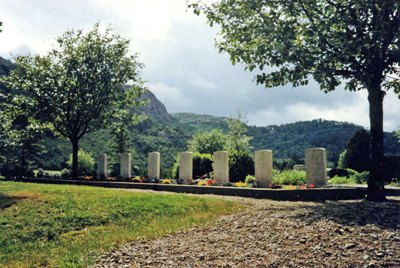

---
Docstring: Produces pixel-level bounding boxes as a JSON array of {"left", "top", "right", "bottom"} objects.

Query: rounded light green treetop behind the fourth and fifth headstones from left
[{"left": 188, "top": 129, "right": 228, "bottom": 154}]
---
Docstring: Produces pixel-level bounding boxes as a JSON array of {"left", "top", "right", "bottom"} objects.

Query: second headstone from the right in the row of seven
[{"left": 255, "top": 150, "right": 272, "bottom": 188}]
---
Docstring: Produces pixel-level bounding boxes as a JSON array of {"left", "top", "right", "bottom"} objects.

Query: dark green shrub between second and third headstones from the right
[{"left": 229, "top": 154, "right": 254, "bottom": 182}]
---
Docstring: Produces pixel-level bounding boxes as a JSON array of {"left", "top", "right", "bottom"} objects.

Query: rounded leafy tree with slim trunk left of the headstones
[{"left": 4, "top": 24, "right": 142, "bottom": 177}]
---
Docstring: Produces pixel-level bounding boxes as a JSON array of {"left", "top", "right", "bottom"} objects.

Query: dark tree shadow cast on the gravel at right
[{"left": 290, "top": 200, "right": 400, "bottom": 230}]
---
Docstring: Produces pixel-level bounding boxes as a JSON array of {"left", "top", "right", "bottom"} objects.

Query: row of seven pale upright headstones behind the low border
[{"left": 97, "top": 148, "right": 327, "bottom": 188}]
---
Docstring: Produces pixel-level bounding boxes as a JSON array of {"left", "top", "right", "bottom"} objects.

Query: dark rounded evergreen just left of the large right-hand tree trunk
[{"left": 340, "top": 128, "right": 371, "bottom": 172}]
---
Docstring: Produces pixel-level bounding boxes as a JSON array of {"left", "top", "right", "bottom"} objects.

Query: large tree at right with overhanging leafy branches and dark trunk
[{"left": 189, "top": 0, "right": 400, "bottom": 201}]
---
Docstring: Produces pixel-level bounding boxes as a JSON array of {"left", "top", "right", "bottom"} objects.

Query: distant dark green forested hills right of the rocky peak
[{"left": 173, "top": 113, "right": 400, "bottom": 162}]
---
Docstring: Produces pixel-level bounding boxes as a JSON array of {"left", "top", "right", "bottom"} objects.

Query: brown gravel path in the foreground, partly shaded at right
[{"left": 94, "top": 193, "right": 400, "bottom": 268}]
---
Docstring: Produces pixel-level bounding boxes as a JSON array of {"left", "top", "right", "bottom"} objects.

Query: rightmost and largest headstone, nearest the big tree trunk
[{"left": 305, "top": 148, "right": 327, "bottom": 187}]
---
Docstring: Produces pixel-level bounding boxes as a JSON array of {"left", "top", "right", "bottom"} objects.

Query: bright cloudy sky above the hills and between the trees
[{"left": 0, "top": 0, "right": 400, "bottom": 131}]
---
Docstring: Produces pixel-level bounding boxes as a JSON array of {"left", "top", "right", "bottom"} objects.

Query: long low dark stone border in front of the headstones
[{"left": 12, "top": 179, "right": 400, "bottom": 201}]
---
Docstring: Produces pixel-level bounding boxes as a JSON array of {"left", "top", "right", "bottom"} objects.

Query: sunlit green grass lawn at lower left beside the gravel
[{"left": 0, "top": 181, "right": 241, "bottom": 267}]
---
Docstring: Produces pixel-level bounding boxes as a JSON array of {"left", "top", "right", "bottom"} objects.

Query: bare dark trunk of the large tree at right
[{"left": 367, "top": 87, "right": 386, "bottom": 201}]
